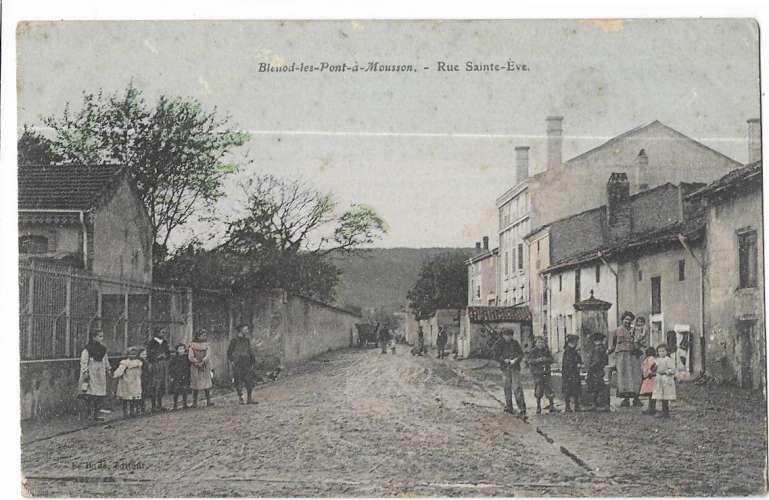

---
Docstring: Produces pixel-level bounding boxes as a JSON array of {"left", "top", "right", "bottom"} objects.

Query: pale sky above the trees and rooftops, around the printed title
[{"left": 17, "top": 19, "right": 759, "bottom": 247}]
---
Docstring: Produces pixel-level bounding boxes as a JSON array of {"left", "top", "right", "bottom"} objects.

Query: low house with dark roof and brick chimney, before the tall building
[{"left": 526, "top": 173, "right": 705, "bottom": 373}]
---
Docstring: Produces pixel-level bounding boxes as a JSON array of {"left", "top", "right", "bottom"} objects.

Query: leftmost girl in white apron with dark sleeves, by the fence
[{"left": 78, "top": 330, "right": 111, "bottom": 420}]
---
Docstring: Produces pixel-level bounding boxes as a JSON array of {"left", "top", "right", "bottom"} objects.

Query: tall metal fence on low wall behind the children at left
[{"left": 19, "top": 262, "right": 193, "bottom": 361}]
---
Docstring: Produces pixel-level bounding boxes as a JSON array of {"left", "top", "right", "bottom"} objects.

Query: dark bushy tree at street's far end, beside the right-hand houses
[{"left": 407, "top": 251, "right": 468, "bottom": 319}]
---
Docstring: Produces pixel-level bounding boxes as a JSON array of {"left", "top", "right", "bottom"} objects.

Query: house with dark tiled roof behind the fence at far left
[{"left": 18, "top": 165, "right": 152, "bottom": 283}]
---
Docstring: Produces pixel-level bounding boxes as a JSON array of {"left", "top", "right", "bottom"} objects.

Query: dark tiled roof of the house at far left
[{"left": 18, "top": 165, "right": 122, "bottom": 210}]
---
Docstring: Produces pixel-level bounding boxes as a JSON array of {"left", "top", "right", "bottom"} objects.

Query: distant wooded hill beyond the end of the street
[{"left": 330, "top": 248, "right": 473, "bottom": 310}]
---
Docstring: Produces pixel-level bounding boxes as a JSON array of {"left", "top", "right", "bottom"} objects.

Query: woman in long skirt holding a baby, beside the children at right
[{"left": 609, "top": 311, "right": 643, "bottom": 407}]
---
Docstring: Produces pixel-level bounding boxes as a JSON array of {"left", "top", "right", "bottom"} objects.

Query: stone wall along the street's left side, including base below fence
[{"left": 20, "top": 290, "right": 361, "bottom": 419}]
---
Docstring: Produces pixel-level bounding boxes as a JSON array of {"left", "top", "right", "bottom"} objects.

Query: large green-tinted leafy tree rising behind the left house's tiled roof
[{"left": 24, "top": 84, "right": 249, "bottom": 262}]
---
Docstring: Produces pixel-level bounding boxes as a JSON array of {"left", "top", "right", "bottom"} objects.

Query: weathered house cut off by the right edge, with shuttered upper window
[{"left": 688, "top": 160, "right": 766, "bottom": 390}]
